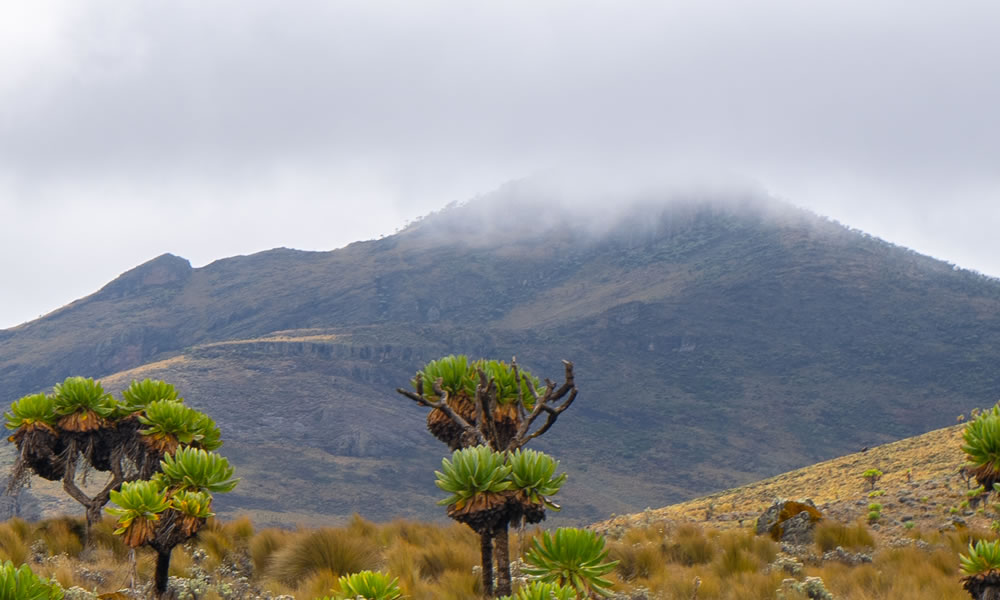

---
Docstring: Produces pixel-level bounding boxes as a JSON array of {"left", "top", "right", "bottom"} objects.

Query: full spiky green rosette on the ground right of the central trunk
[{"left": 523, "top": 528, "right": 618, "bottom": 596}]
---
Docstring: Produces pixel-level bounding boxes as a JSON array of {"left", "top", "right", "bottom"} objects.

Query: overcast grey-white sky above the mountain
[{"left": 0, "top": 0, "right": 1000, "bottom": 327}]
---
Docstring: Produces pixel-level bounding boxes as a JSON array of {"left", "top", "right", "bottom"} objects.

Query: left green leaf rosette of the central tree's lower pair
[{"left": 434, "top": 446, "right": 513, "bottom": 509}]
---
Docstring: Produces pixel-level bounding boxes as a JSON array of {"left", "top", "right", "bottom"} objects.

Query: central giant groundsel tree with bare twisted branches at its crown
[{"left": 396, "top": 355, "right": 577, "bottom": 595}]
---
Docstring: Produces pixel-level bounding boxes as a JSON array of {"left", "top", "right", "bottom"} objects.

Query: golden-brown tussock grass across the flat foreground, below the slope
[{"left": 0, "top": 516, "right": 996, "bottom": 600}]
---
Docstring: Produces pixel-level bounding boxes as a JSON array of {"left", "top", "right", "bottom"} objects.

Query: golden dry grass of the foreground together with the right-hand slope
[{"left": 0, "top": 427, "right": 984, "bottom": 600}]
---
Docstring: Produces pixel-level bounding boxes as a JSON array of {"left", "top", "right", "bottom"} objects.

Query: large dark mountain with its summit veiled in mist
[{"left": 0, "top": 181, "right": 1000, "bottom": 523}]
